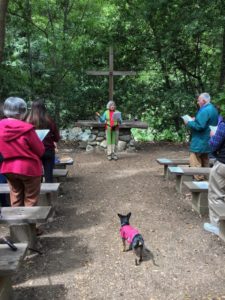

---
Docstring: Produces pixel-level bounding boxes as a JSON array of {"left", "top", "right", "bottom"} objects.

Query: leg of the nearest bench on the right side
[{"left": 192, "top": 192, "right": 209, "bottom": 216}]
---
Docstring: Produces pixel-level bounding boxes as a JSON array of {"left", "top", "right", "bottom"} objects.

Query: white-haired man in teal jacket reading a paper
[{"left": 184, "top": 93, "right": 218, "bottom": 180}]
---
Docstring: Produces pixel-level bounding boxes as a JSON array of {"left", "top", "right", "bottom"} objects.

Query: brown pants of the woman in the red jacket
[{"left": 5, "top": 174, "right": 41, "bottom": 206}]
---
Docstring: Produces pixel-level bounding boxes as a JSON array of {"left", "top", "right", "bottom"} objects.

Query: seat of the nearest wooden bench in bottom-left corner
[{"left": 0, "top": 243, "right": 27, "bottom": 277}]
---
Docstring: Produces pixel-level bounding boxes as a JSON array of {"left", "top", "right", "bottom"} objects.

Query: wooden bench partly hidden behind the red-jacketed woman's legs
[{"left": 0, "top": 183, "right": 60, "bottom": 206}]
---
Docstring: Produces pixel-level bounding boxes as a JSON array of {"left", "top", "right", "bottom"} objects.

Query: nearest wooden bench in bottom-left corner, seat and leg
[{"left": 0, "top": 243, "right": 27, "bottom": 300}]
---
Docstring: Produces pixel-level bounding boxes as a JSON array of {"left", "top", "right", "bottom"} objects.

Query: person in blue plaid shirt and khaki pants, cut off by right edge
[{"left": 204, "top": 116, "right": 225, "bottom": 235}]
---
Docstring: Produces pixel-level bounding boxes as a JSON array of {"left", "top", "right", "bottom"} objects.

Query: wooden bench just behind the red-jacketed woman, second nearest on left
[{"left": 0, "top": 206, "right": 52, "bottom": 248}]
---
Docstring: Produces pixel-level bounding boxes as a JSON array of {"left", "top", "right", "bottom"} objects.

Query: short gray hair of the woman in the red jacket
[{"left": 3, "top": 97, "right": 27, "bottom": 118}]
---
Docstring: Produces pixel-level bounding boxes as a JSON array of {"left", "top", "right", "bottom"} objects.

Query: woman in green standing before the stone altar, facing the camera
[{"left": 96, "top": 101, "right": 122, "bottom": 160}]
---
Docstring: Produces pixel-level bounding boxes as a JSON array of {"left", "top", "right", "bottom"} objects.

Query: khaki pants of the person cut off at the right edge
[{"left": 208, "top": 161, "right": 225, "bottom": 226}]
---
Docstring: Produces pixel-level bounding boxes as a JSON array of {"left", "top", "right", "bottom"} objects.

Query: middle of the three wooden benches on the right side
[{"left": 168, "top": 166, "right": 211, "bottom": 193}]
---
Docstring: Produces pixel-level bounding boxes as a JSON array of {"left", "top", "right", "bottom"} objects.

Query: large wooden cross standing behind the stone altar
[{"left": 87, "top": 47, "right": 136, "bottom": 100}]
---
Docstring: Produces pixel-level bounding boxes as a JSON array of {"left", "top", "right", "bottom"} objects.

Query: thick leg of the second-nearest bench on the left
[{"left": 10, "top": 223, "right": 37, "bottom": 248}]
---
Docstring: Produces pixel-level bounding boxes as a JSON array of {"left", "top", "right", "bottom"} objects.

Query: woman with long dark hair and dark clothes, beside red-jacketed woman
[{"left": 26, "top": 101, "right": 60, "bottom": 183}]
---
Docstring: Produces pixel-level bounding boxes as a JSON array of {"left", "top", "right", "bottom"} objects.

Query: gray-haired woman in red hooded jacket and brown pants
[{"left": 0, "top": 97, "right": 45, "bottom": 206}]
